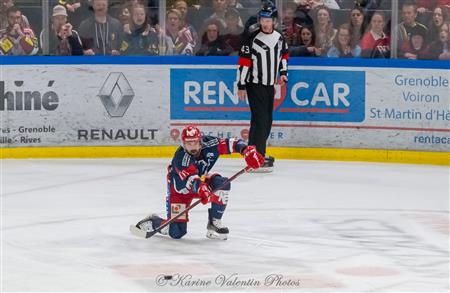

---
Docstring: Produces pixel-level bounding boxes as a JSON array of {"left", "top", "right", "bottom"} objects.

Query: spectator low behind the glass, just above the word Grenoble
[{"left": 399, "top": 26, "right": 430, "bottom": 60}]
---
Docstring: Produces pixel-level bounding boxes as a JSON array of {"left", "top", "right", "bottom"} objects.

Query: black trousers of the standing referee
[{"left": 246, "top": 83, "right": 275, "bottom": 156}]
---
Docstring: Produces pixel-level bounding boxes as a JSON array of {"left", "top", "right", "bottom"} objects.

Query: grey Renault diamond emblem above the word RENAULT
[{"left": 97, "top": 72, "right": 134, "bottom": 117}]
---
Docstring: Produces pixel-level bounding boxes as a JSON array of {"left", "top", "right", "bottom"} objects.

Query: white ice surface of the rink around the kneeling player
[{"left": 0, "top": 159, "right": 450, "bottom": 292}]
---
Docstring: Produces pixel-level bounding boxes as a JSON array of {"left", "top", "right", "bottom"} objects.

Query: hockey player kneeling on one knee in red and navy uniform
[{"left": 136, "top": 125, "right": 264, "bottom": 240}]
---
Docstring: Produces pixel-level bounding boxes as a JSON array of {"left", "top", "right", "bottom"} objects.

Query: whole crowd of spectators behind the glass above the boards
[{"left": 0, "top": 0, "right": 450, "bottom": 60}]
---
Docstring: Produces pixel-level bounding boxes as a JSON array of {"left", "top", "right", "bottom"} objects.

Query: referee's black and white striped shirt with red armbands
[{"left": 238, "top": 30, "right": 288, "bottom": 89}]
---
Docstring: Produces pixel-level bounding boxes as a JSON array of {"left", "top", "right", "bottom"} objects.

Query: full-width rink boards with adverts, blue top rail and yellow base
[{"left": 0, "top": 57, "right": 450, "bottom": 165}]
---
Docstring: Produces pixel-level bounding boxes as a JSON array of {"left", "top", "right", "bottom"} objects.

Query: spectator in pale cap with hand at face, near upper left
[{"left": 39, "top": 5, "right": 83, "bottom": 56}]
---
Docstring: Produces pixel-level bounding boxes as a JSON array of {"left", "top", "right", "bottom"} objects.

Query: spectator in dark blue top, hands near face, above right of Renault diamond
[{"left": 120, "top": 4, "right": 159, "bottom": 56}]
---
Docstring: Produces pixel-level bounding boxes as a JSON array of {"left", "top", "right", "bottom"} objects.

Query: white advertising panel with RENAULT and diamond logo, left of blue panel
[{"left": 0, "top": 65, "right": 169, "bottom": 147}]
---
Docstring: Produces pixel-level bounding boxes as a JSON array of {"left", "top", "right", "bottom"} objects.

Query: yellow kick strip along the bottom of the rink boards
[{"left": 0, "top": 146, "right": 450, "bottom": 166}]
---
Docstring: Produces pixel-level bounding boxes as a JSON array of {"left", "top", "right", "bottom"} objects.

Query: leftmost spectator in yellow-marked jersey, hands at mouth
[{"left": 0, "top": 6, "right": 39, "bottom": 56}]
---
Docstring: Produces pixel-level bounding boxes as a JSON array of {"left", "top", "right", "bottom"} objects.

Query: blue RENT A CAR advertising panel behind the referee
[{"left": 170, "top": 69, "right": 366, "bottom": 122}]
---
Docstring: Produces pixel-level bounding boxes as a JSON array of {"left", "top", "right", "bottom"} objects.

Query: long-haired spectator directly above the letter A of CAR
[{"left": 314, "top": 6, "right": 337, "bottom": 55}]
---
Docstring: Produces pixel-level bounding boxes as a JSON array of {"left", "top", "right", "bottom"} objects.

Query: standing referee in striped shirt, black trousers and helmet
[{"left": 238, "top": 1, "right": 288, "bottom": 171}]
